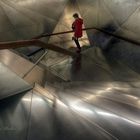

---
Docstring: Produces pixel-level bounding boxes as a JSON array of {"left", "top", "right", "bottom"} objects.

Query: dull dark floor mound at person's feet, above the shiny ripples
[{"left": 47, "top": 48, "right": 140, "bottom": 82}]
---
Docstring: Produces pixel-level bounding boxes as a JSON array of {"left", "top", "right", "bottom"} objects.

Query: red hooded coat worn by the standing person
[{"left": 72, "top": 18, "right": 83, "bottom": 38}]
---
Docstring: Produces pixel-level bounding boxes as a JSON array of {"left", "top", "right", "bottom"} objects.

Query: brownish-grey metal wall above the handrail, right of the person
[{"left": 77, "top": 0, "right": 140, "bottom": 45}]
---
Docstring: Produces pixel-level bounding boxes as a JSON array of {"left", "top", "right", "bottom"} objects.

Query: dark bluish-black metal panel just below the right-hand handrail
[{"left": 103, "top": 38, "right": 140, "bottom": 76}]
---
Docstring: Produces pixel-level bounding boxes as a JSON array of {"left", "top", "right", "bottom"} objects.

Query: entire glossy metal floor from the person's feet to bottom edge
[{"left": 0, "top": 48, "right": 140, "bottom": 140}]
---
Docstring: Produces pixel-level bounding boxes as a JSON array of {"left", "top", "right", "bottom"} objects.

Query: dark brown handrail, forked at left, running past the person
[{"left": 0, "top": 27, "right": 140, "bottom": 56}]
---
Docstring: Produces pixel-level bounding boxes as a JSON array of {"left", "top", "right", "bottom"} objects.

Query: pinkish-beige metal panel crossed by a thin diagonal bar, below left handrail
[{"left": 0, "top": 50, "right": 44, "bottom": 84}]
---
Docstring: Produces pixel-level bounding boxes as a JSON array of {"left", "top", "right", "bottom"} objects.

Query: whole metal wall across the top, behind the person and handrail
[{"left": 0, "top": 0, "right": 140, "bottom": 55}]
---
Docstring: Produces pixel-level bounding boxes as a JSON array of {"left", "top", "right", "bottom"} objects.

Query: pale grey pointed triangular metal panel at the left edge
[{"left": 0, "top": 63, "right": 32, "bottom": 99}]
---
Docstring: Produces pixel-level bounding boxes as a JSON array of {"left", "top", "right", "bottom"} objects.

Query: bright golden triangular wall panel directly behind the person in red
[{"left": 43, "top": 1, "right": 90, "bottom": 66}]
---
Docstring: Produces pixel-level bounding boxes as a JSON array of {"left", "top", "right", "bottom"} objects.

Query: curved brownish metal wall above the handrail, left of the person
[{"left": 0, "top": 0, "right": 67, "bottom": 41}]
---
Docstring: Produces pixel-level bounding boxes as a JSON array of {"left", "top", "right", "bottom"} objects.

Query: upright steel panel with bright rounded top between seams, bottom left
[{"left": 28, "top": 92, "right": 56, "bottom": 140}]
